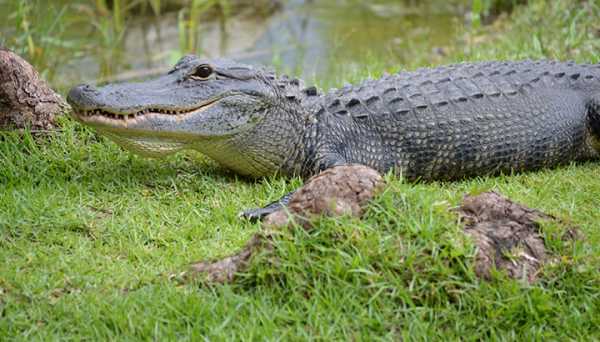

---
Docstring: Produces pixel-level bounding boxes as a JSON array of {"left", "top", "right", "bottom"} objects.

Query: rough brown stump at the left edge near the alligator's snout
[{"left": 0, "top": 46, "right": 68, "bottom": 130}]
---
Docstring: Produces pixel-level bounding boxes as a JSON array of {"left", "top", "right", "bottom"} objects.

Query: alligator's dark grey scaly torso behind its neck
[{"left": 314, "top": 61, "right": 600, "bottom": 179}]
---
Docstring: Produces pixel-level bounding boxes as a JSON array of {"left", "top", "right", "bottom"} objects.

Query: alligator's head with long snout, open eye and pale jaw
[{"left": 67, "top": 55, "right": 306, "bottom": 176}]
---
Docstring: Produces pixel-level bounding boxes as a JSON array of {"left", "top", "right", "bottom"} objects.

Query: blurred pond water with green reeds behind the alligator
[{"left": 0, "top": 0, "right": 536, "bottom": 91}]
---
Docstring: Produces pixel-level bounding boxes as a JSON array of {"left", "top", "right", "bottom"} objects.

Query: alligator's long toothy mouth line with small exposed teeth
[{"left": 74, "top": 98, "right": 220, "bottom": 125}]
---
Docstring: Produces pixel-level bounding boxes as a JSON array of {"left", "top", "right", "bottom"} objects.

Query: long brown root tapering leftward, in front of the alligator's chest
[{"left": 184, "top": 165, "right": 383, "bottom": 283}]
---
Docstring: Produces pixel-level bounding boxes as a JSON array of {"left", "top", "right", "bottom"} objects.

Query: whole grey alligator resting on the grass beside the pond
[{"left": 67, "top": 55, "right": 600, "bottom": 217}]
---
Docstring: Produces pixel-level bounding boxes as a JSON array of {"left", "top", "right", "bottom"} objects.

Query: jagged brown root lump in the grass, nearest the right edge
[{"left": 457, "top": 192, "right": 581, "bottom": 283}]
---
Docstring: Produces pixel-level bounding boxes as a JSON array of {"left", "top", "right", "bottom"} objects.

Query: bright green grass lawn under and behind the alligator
[{"left": 0, "top": 0, "right": 600, "bottom": 340}]
